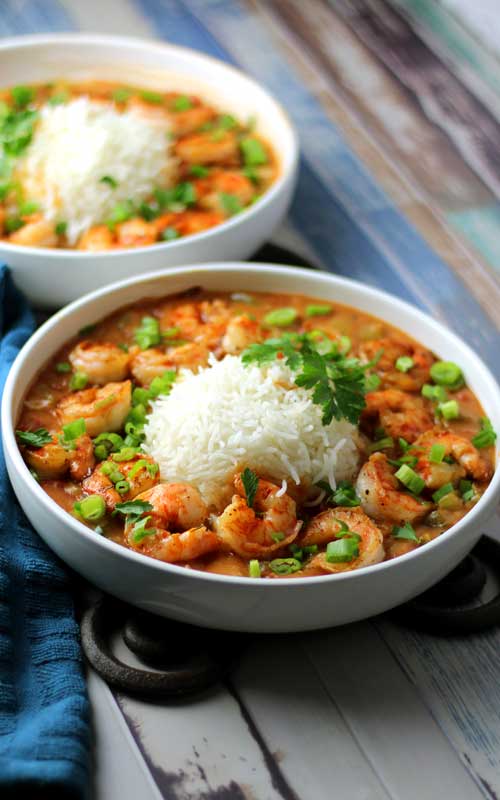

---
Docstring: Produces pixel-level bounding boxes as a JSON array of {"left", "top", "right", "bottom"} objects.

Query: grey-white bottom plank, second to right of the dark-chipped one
[{"left": 304, "top": 623, "right": 483, "bottom": 800}]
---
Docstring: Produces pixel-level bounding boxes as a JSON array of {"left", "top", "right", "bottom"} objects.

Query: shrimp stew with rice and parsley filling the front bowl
[{"left": 17, "top": 288, "right": 496, "bottom": 580}]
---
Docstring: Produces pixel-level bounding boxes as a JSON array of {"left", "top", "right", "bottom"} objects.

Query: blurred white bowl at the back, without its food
[{"left": 0, "top": 33, "right": 299, "bottom": 308}]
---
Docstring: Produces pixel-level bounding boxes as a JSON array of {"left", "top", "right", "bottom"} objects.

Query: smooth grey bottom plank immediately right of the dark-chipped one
[{"left": 232, "top": 631, "right": 390, "bottom": 800}]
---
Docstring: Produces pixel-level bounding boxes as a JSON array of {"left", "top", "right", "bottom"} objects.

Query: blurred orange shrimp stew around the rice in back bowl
[{"left": 0, "top": 81, "right": 279, "bottom": 251}]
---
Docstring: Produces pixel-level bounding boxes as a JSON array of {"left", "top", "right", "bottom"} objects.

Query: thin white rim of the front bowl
[{"left": 1, "top": 262, "right": 500, "bottom": 591}]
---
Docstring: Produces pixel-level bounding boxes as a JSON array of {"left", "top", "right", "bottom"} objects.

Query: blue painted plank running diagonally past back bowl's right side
[{"left": 149, "top": 0, "right": 498, "bottom": 364}]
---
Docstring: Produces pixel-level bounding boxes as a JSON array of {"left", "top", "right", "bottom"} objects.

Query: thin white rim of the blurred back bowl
[{"left": 0, "top": 32, "right": 300, "bottom": 261}]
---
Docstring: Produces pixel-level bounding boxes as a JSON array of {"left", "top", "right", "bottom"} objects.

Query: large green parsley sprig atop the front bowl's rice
[{"left": 242, "top": 334, "right": 372, "bottom": 425}]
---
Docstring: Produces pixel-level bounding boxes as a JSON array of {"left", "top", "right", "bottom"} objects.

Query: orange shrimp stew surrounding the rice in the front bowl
[{"left": 18, "top": 289, "right": 495, "bottom": 579}]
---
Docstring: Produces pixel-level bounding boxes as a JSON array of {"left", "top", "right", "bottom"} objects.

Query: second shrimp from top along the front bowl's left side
[{"left": 57, "top": 381, "right": 132, "bottom": 436}]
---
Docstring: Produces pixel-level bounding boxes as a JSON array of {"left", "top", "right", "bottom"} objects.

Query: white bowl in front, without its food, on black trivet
[{"left": 2, "top": 263, "right": 500, "bottom": 632}]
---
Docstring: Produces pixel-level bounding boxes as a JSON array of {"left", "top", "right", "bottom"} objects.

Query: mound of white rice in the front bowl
[{"left": 144, "top": 356, "right": 358, "bottom": 504}]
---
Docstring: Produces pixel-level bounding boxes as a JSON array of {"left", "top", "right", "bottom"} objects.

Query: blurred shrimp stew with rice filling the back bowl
[{"left": 0, "top": 80, "right": 279, "bottom": 251}]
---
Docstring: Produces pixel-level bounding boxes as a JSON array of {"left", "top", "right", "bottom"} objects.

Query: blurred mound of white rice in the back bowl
[{"left": 17, "top": 97, "right": 172, "bottom": 244}]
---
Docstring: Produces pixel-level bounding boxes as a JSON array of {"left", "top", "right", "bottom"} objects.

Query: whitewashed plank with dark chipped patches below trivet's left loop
[{"left": 109, "top": 642, "right": 294, "bottom": 800}]
